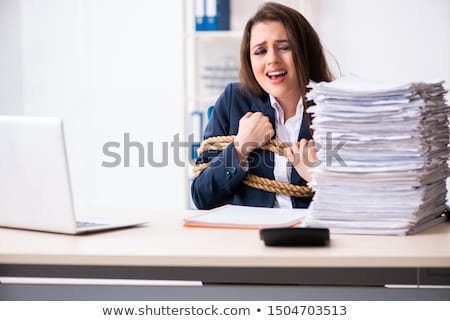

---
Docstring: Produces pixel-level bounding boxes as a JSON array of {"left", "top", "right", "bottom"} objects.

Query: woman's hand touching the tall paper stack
[{"left": 287, "top": 138, "right": 317, "bottom": 182}]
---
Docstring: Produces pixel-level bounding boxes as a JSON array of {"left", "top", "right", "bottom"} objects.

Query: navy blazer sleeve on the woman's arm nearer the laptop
[{"left": 191, "top": 85, "right": 247, "bottom": 209}]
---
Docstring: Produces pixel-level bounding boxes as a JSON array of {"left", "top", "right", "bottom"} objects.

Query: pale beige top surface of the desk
[{"left": 0, "top": 210, "right": 450, "bottom": 268}]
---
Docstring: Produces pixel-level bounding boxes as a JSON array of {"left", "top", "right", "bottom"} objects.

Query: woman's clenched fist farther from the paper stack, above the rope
[{"left": 234, "top": 112, "right": 275, "bottom": 161}]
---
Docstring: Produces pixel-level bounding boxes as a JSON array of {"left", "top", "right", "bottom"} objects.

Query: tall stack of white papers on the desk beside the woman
[{"left": 307, "top": 75, "right": 449, "bottom": 235}]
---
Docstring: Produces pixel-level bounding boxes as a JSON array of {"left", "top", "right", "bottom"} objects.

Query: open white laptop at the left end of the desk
[{"left": 0, "top": 115, "right": 147, "bottom": 234}]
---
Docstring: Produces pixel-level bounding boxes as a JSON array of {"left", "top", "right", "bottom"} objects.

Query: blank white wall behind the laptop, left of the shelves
[{"left": 0, "top": 0, "right": 186, "bottom": 209}]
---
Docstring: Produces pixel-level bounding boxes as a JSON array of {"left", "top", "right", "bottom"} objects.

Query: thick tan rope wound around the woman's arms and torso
[{"left": 193, "top": 136, "right": 314, "bottom": 197}]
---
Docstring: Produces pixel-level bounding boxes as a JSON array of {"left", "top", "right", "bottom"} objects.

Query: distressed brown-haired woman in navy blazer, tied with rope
[{"left": 191, "top": 3, "right": 332, "bottom": 209}]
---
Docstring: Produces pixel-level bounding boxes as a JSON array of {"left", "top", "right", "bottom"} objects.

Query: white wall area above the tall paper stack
[{"left": 310, "top": 0, "right": 450, "bottom": 88}]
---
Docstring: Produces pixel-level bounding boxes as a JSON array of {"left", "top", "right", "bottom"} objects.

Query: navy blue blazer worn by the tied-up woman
[{"left": 191, "top": 83, "right": 311, "bottom": 209}]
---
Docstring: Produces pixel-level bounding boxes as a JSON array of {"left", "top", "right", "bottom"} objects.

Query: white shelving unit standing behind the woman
[{"left": 183, "top": 0, "right": 311, "bottom": 208}]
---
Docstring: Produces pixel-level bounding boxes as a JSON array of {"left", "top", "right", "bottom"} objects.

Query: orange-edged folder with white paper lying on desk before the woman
[{"left": 184, "top": 205, "right": 308, "bottom": 229}]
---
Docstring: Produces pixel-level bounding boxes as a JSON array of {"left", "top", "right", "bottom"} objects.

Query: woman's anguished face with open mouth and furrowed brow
[{"left": 250, "top": 21, "right": 301, "bottom": 103}]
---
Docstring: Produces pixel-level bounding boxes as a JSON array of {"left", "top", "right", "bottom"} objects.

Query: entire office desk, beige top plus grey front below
[{"left": 0, "top": 210, "right": 450, "bottom": 300}]
